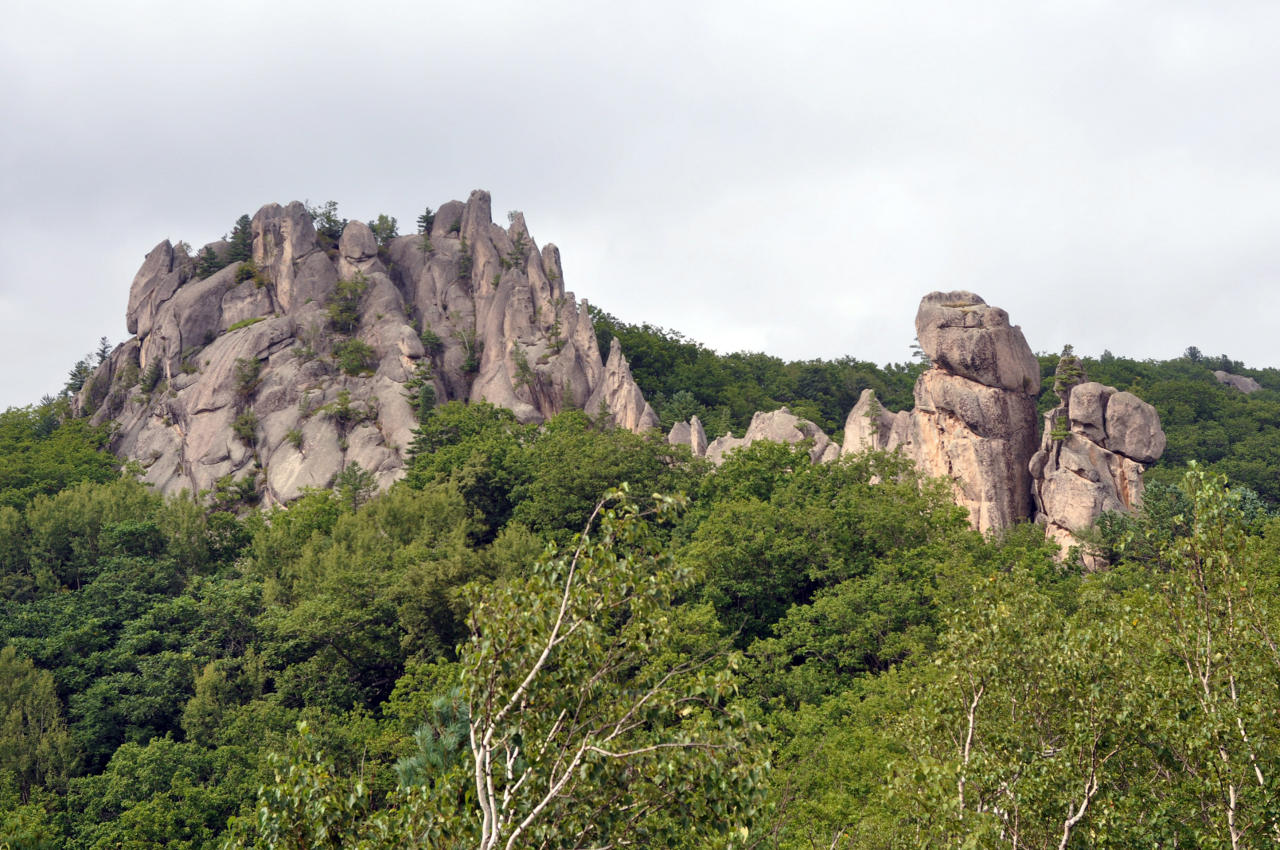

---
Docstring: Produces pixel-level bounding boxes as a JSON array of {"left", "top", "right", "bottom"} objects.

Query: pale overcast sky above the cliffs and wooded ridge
[{"left": 0, "top": 0, "right": 1280, "bottom": 407}]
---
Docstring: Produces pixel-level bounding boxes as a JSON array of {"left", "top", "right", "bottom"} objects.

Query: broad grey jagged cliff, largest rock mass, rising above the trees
[{"left": 78, "top": 192, "right": 657, "bottom": 502}]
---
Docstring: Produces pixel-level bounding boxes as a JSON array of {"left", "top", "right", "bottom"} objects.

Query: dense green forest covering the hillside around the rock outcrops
[{"left": 0, "top": 330, "right": 1280, "bottom": 850}]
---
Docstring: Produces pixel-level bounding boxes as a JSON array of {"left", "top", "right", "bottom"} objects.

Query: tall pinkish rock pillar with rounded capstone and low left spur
[{"left": 841, "top": 292, "right": 1039, "bottom": 531}]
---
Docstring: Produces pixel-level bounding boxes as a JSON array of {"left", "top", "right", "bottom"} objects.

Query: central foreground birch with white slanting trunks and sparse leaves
[{"left": 462, "top": 489, "right": 759, "bottom": 850}]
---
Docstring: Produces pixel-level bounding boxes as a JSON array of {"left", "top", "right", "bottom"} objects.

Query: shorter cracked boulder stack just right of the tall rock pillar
[{"left": 1029, "top": 352, "right": 1165, "bottom": 549}]
